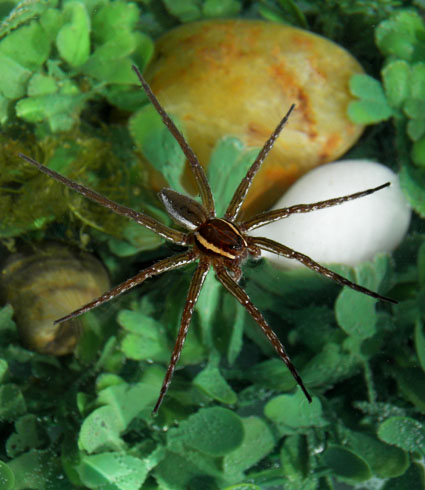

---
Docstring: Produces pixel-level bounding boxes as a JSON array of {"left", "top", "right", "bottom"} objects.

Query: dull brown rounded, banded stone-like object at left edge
[{"left": 1, "top": 244, "right": 109, "bottom": 356}]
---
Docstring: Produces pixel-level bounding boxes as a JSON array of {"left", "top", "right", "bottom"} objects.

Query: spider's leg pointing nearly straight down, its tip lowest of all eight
[{"left": 153, "top": 261, "right": 210, "bottom": 414}]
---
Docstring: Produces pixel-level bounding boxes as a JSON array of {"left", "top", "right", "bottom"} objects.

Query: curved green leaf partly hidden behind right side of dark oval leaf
[{"left": 223, "top": 417, "right": 275, "bottom": 475}]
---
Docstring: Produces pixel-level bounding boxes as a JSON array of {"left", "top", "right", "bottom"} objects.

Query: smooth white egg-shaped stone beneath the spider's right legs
[{"left": 251, "top": 160, "right": 411, "bottom": 267}]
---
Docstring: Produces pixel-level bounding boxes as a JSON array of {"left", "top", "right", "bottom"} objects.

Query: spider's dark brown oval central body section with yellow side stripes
[{"left": 194, "top": 218, "right": 248, "bottom": 259}]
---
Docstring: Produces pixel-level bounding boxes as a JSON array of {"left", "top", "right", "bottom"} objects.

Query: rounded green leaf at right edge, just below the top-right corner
[{"left": 375, "top": 9, "right": 425, "bottom": 61}]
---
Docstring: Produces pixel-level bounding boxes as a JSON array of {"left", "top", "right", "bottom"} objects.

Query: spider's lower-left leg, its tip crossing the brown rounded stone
[{"left": 53, "top": 250, "right": 198, "bottom": 325}]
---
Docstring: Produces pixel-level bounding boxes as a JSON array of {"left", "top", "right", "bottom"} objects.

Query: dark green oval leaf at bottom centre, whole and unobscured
[{"left": 173, "top": 407, "right": 244, "bottom": 457}]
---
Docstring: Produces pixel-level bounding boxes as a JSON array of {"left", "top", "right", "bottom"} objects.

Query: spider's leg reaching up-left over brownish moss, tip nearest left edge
[{"left": 19, "top": 153, "right": 186, "bottom": 245}]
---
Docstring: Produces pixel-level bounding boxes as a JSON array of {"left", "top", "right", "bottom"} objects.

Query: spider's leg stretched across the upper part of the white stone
[{"left": 239, "top": 182, "right": 391, "bottom": 232}]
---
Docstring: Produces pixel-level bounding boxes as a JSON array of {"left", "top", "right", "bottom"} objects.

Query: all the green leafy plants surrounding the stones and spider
[{"left": 0, "top": 0, "right": 425, "bottom": 490}]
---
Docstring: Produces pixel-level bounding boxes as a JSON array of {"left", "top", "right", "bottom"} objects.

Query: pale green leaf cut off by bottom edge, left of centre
[{"left": 77, "top": 452, "right": 148, "bottom": 490}]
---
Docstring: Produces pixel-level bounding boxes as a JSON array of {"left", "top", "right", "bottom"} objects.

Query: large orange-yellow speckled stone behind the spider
[{"left": 146, "top": 20, "right": 363, "bottom": 214}]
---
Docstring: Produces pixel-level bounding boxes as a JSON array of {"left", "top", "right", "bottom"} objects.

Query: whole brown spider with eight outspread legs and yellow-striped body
[{"left": 19, "top": 65, "right": 397, "bottom": 414}]
